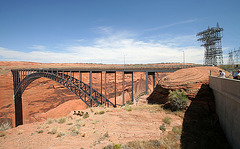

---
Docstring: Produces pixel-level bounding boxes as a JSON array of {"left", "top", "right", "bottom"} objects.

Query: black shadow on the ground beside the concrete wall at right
[{"left": 180, "top": 84, "right": 231, "bottom": 149}]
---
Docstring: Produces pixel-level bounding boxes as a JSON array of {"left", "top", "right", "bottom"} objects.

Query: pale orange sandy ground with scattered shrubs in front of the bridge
[{"left": 0, "top": 106, "right": 183, "bottom": 149}]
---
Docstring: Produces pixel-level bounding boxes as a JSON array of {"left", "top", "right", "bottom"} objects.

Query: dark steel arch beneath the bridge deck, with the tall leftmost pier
[{"left": 12, "top": 70, "right": 116, "bottom": 126}]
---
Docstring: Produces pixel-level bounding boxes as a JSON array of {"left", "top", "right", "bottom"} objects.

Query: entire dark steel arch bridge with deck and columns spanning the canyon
[{"left": 11, "top": 66, "right": 189, "bottom": 126}]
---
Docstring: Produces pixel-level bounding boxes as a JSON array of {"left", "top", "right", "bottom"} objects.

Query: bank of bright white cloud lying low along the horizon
[{"left": 0, "top": 33, "right": 204, "bottom": 64}]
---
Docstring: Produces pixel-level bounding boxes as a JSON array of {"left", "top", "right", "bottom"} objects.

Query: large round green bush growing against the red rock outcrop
[{"left": 168, "top": 90, "right": 189, "bottom": 111}]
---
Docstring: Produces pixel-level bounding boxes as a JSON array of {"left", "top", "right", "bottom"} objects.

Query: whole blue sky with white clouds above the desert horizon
[{"left": 0, "top": 0, "right": 240, "bottom": 64}]
